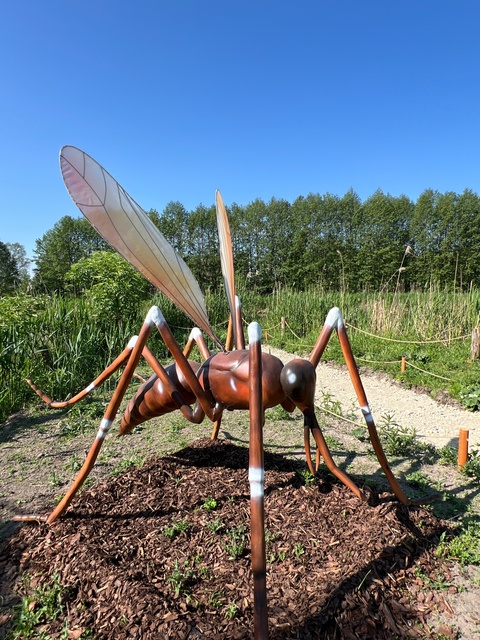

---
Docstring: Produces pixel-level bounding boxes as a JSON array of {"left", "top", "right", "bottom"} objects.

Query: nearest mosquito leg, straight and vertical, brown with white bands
[{"left": 248, "top": 322, "right": 268, "bottom": 640}]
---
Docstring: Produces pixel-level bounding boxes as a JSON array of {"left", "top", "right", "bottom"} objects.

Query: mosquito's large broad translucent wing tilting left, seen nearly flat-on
[{"left": 60, "top": 146, "right": 221, "bottom": 346}]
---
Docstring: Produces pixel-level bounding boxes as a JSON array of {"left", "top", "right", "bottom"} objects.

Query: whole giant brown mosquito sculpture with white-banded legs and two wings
[{"left": 15, "top": 146, "right": 411, "bottom": 640}]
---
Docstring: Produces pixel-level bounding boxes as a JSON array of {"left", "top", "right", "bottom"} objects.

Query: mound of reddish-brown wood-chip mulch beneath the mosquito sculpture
[{"left": 0, "top": 440, "right": 458, "bottom": 640}]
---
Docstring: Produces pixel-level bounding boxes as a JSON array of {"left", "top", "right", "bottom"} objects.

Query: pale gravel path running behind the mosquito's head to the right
[{"left": 267, "top": 347, "right": 480, "bottom": 449}]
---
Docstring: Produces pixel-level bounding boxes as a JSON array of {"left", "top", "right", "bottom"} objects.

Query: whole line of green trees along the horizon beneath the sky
[{"left": 0, "top": 189, "right": 480, "bottom": 293}]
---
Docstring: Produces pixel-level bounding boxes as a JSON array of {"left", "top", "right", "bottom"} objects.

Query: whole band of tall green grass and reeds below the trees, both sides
[{"left": 0, "top": 287, "right": 480, "bottom": 420}]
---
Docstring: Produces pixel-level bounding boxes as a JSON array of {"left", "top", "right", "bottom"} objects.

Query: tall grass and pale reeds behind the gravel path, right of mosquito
[{"left": 237, "top": 287, "right": 480, "bottom": 397}]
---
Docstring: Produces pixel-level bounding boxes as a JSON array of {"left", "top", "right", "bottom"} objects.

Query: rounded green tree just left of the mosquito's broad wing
[{"left": 34, "top": 216, "right": 109, "bottom": 291}]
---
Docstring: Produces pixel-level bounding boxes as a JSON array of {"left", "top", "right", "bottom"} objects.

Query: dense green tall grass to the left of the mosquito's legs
[{"left": 0, "top": 295, "right": 144, "bottom": 420}]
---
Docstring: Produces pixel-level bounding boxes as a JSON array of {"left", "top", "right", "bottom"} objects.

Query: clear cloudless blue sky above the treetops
[{"left": 0, "top": 0, "right": 480, "bottom": 256}]
